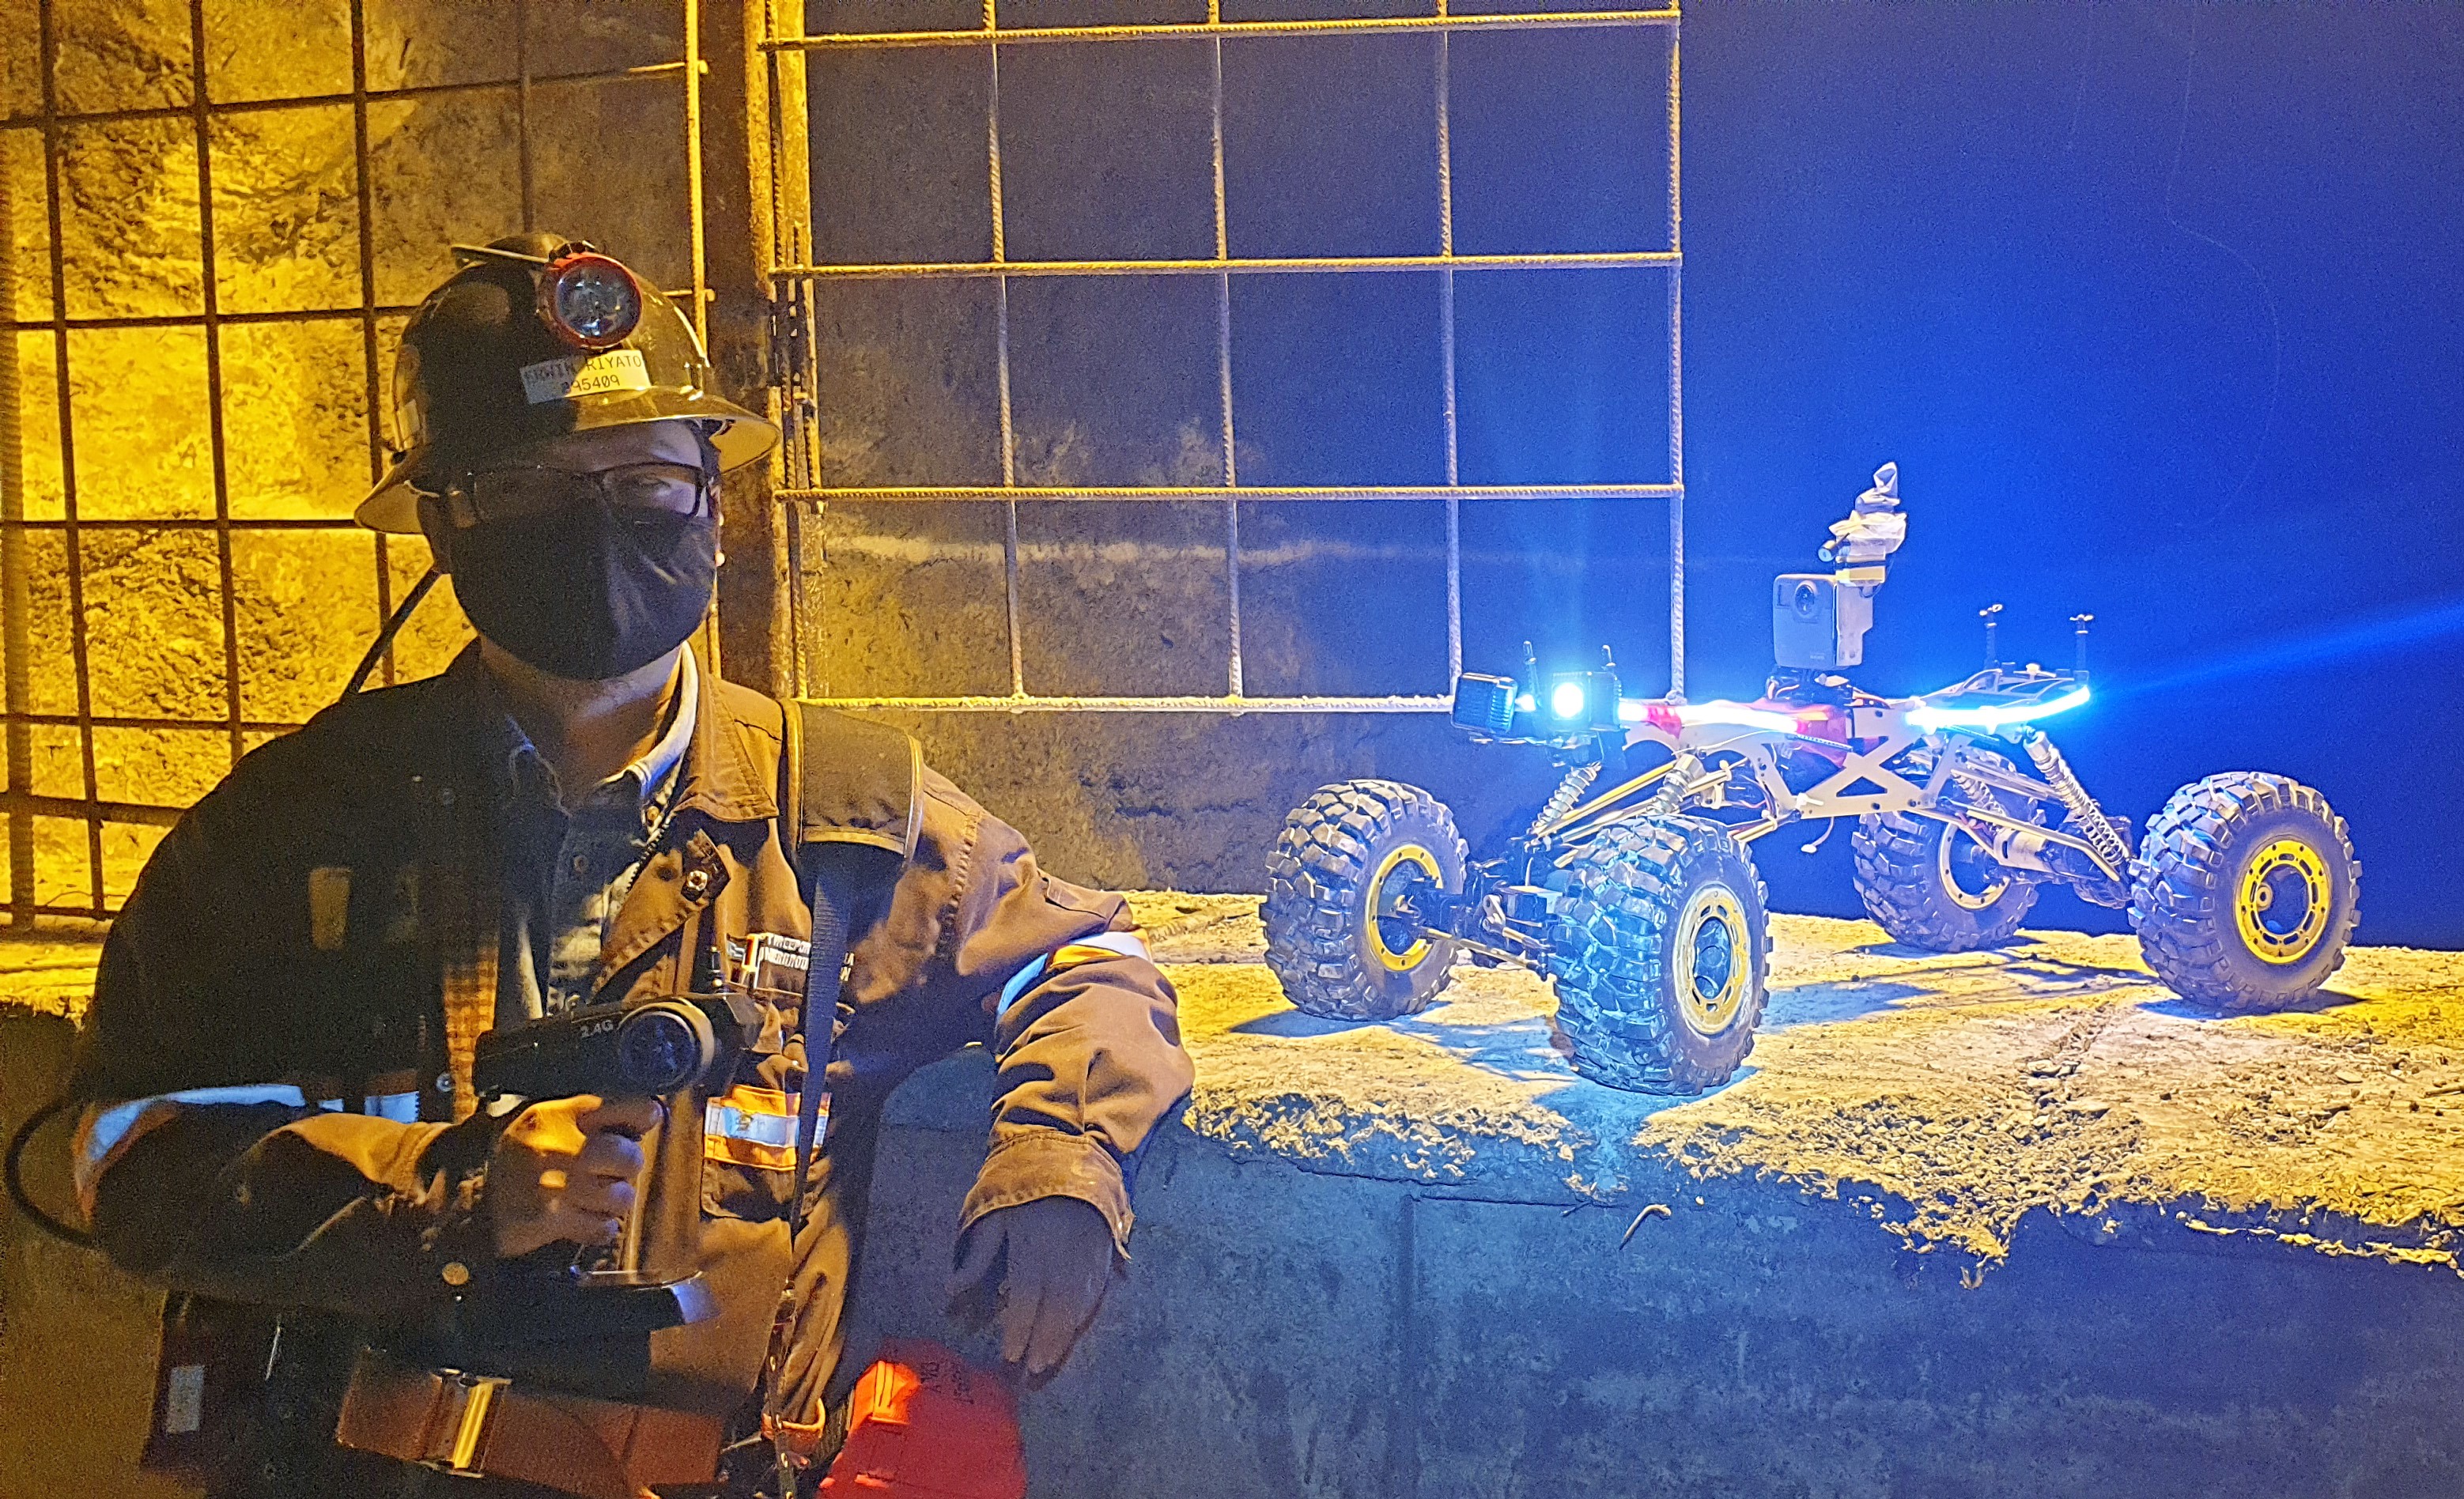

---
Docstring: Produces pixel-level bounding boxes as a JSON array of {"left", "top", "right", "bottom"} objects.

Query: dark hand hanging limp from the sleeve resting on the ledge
[{"left": 949, "top": 1199, "right": 1117, "bottom": 1378}]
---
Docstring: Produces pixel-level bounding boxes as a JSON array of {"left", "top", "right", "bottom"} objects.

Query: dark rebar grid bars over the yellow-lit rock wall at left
[{"left": 0, "top": 0, "right": 707, "bottom": 927}]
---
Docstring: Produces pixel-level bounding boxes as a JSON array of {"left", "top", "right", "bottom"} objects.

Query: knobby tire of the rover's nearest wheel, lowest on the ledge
[{"left": 1550, "top": 816, "right": 1771, "bottom": 1095}]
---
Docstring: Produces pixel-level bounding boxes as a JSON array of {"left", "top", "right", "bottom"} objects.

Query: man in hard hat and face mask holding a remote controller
[{"left": 58, "top": 234, "right": 1190, "bottom": 1499}]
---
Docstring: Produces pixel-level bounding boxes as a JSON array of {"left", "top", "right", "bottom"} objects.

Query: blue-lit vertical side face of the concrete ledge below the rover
[{"left": 855, "top": 1053, "right": 2464, "bottom": 1499}]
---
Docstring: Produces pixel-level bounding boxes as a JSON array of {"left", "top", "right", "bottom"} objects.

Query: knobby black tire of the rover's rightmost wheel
[{"left": 2131, "top": 769, "right": 2360, "bottom": 1011}]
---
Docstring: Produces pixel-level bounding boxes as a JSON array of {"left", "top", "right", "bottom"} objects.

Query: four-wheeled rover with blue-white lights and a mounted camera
[{"left": 1264, "top": 466, "right": 2360, "bottom": 1095}]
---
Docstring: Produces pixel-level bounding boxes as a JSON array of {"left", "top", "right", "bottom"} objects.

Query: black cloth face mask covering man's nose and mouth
[{"left": 453, "top": 498, "right": 720, "bottom": 681}]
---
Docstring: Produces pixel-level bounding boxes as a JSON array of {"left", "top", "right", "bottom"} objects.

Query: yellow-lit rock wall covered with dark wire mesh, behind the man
[{"left": 0, "top": 0, "right": 705, "bottom": 927}]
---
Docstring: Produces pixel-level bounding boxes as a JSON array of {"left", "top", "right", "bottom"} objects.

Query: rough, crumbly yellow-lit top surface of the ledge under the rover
[{"left": 0, "top": 893, "right": 2464, "bottom": 1270}]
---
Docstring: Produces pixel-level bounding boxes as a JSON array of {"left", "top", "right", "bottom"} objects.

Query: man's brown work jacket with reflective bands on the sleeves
[{"left": 74, "top": 651, "right": 1190, "bottom": 1413}]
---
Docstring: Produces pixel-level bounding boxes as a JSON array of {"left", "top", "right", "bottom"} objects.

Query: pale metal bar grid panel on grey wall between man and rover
[{"left": 764, "top": 0, "right": 1685, "bottom": 712}]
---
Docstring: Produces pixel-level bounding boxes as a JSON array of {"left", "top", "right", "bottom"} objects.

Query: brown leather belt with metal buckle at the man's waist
[{"left": 335, "top": 1349, "right": 722, "bottom": 1499}]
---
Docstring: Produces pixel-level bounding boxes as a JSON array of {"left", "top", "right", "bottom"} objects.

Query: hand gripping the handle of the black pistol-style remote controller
[{"left": 483, "top": 1095, "right": 663, "bottom": 1260}]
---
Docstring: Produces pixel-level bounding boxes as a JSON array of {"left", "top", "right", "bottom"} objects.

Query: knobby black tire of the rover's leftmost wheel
[{"left": 1261, "top": 782, "right": 1468, "bottom": 1021}]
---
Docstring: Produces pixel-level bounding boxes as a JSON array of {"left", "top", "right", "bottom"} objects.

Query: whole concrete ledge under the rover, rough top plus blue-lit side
[{"left": 855, "top": 897, "right": 2464, "bottom": 1499}]
